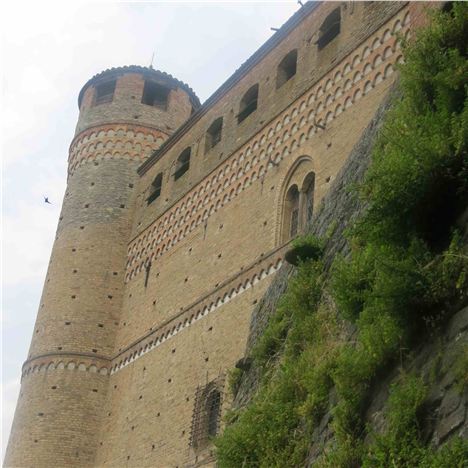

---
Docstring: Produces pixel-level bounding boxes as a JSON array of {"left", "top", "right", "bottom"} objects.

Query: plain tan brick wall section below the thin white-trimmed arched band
[{"left": 97, "top": 280, "right": 269, "bottom": 467}]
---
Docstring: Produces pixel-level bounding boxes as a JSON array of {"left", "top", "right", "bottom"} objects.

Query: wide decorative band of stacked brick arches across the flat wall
[{"left": 125, "top": 8, "right": 410, "bottom": 282}]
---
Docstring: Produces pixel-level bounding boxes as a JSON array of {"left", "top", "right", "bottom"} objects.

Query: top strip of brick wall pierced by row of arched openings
[{"left": 133, "top": 2, "right": 405, "bottom": 236}]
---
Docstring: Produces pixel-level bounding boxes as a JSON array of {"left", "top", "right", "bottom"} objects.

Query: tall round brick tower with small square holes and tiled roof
[{"left": 5, "top": 66, "right": 200, "bottom": 468}]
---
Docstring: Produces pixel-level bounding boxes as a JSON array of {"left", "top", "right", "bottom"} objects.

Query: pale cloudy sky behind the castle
[{"left": 0, "top": 0, "right": 299, "bottom": 459}]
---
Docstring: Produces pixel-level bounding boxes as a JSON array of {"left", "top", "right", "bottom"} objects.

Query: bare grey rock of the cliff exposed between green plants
[{"left": 234, "top": 82, "right": 468, "bottom": 458}]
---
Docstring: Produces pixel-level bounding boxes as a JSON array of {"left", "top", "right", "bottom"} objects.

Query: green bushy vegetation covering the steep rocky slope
[{"left": 215, "top": 2, "right": 468, "bottom": 468}]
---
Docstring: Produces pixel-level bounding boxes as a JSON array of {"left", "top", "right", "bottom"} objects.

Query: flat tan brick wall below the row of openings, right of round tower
[{"left": 98, "top": 2, "right": 409, "bottom": 466}]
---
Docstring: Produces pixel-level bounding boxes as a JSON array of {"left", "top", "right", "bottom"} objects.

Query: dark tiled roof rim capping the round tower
[{"left": 78, "top": 65, "right": 201, "bottom": 109}]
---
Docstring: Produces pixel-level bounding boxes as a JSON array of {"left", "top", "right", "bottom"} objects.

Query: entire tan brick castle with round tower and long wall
[{"left": 5, "top": 2, "right": 436, "bottom": 468}]
